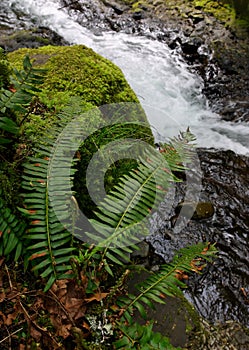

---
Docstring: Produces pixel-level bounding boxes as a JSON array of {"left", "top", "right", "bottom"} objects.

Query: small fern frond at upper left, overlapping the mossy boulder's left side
[{"left": 0, "top": 56, "right": 46, "bottom": 113}]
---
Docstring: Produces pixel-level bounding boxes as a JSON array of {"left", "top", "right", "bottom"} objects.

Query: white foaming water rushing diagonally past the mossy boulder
[{"left": 0, "top": 0, "right": 249, "bottom": 154}]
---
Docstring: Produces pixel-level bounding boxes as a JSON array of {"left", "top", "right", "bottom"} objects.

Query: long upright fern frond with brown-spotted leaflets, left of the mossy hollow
[{"left": 22, "top": 98, "right": 103, "bottom": 290}]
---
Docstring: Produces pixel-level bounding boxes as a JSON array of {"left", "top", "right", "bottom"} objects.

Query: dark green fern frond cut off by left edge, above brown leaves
[{"left": 0, "top": 191, "right": 26, "bottom": 261}]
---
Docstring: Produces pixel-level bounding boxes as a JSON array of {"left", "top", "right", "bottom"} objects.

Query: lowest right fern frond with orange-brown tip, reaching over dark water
[{"left": 117, "top": 243, "right": 217, "bottom": 322}]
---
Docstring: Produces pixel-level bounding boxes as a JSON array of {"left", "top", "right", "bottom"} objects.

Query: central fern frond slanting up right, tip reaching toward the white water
[{"left": 87, "top": 131, "right": 196, "bottom": 271}]
